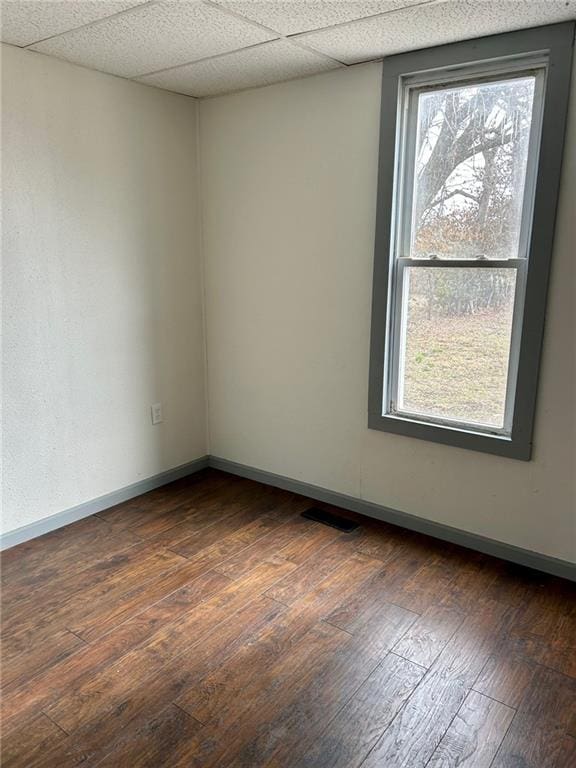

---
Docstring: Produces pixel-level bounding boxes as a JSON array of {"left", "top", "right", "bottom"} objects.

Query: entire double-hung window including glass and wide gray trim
[{"left": 369, "top": 24, "right": 574, "bottom": 460}]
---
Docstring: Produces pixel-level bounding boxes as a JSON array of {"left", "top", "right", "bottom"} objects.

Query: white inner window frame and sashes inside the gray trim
[{"left": 390, "top": 60, "right": 548, "bottom": 437}]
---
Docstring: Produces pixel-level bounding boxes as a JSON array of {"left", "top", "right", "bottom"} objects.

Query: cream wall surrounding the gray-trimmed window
[{"left": 201, "top": 64, "right": 576, "bottom": 561}]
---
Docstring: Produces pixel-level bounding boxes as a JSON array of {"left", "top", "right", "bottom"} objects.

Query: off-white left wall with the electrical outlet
[{"left": 2, "top": 46, "right": 207, "bottom": 531}]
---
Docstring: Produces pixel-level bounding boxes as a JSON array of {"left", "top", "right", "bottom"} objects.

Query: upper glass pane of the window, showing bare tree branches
[{"left": 410, "top": 76, "right": 535, "bottom": 259}]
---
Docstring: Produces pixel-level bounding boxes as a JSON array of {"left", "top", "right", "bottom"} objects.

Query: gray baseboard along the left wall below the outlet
[{"left": 0, "top": 456, "right": 209, "bottom": 550}]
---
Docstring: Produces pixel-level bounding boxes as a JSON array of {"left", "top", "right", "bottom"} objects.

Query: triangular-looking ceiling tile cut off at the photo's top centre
[{"left": 215, "top": 0, "right": 432, "bottom": 35}]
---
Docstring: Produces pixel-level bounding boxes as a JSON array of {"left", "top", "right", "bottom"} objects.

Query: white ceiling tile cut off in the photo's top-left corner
[{"left": 0, "top": 0, "right": 145, "bottom": 46}]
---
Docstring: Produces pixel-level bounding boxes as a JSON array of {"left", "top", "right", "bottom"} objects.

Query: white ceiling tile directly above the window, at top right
[{"left": 297, "top": 0, "right": 576, "bottom": 64}]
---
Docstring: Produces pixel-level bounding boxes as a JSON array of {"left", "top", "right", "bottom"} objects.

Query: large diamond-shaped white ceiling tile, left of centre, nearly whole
[{"left": 32, "top": 0, "right": 275, "bottom": 77}]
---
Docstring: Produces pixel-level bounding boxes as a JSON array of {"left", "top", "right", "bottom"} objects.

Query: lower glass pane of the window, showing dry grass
[{"left": 397, "top": 267, "right": 516, "bottom": 429}]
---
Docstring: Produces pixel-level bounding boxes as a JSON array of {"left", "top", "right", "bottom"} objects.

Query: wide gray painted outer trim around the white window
[{"left": 368, "top": 22, "right": 575, "bottom": 461}]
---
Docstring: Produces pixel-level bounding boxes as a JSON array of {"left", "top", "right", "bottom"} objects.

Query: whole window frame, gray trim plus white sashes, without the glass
[{"left": 368, "top": 22, "right": 575, "bottom": 461}]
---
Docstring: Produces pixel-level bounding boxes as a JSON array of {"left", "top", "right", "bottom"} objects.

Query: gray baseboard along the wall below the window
[{"left": 209, "top": 456, "right": 576, "bottom": 581}]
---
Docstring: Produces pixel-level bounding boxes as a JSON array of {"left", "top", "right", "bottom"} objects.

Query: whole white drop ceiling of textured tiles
[{"left": 0, "top": 0, "right": 576, "bottom": 97}]
